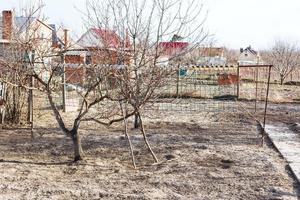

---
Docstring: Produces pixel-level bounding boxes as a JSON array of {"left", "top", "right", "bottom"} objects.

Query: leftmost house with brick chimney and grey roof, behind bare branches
[{"left": 0, "top": 10, "right": 65, "bottom": 80}]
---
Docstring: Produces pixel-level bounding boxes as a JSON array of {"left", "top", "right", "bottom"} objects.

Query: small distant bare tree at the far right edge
[{"left": 262, "top": 40, "right": 300, "bottom": 85}]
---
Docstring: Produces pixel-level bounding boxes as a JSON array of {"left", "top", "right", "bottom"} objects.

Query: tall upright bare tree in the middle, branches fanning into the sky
[{"left": 85, "top": 0, "right": 208, "bottom": 162}]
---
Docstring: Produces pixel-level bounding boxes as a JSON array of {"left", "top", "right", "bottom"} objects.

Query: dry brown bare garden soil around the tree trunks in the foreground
[{"left": 0, "top": 102, "right": 299, "bottom": 200}]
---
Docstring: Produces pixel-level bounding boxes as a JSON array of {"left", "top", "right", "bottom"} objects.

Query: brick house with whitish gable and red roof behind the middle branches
[{"left": 65, "top": 28, "right": 131, "bottom": 84}]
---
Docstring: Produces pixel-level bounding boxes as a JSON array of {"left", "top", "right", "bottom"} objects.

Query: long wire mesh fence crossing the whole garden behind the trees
[{"left": 22, "top": 65, "right": 300, "bottom": 129}]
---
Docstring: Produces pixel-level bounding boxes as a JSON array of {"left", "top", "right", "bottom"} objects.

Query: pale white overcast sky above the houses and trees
[{"left": 0, "top": 0, "right": 300, "bottom": 49}]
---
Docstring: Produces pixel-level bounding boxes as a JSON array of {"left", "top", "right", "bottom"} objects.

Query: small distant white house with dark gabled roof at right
[{"left": 238, "top": 46, "right": 263, "bottom": 65}]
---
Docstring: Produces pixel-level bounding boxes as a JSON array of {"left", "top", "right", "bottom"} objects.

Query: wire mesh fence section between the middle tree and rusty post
[{"left": 150, "top": 66, "right": 238, "bottom": 112}]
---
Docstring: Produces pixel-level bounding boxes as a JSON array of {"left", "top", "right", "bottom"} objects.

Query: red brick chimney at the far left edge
[{"left": 2, "top": 10, "right": 13, "bottom": 40}]
